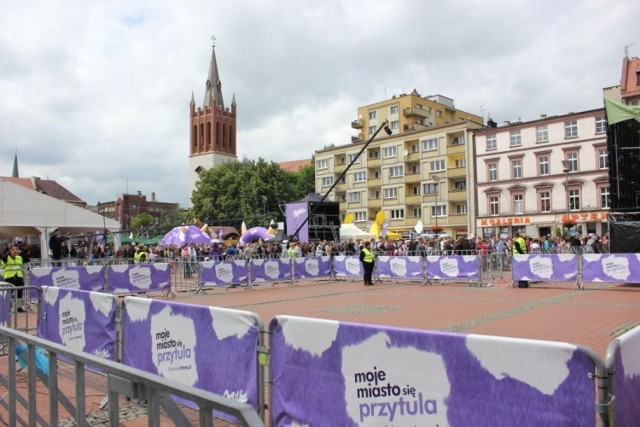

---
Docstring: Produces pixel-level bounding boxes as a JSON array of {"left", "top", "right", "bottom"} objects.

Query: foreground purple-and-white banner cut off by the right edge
[{"left": 606, "top": 326, "right": 640, "bottom": 426}]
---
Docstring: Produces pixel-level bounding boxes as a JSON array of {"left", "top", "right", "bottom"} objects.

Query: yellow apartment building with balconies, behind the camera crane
[{"left": 315, "top": 90, "right": 483, "bottom": 241}]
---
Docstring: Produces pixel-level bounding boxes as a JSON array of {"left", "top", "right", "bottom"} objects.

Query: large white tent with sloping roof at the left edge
[{"left": 0, "top": 180, "right": 120, "bottom": 258}]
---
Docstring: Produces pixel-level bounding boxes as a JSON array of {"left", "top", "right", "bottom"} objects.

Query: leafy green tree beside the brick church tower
[{"left": 189, "top": 158, "right": 315, "bottom": 230}]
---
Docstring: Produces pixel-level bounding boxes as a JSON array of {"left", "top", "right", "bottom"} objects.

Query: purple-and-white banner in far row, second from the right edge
[{"left": 511, "top": 254, "right": 578, "bottom": 282}]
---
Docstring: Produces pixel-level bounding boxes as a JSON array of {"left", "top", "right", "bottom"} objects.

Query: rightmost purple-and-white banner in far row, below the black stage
[{"left": 582, "top": 254, "right": 640, "bottom": 283}]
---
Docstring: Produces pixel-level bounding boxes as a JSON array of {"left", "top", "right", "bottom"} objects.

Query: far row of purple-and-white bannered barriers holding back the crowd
[{"left": 27, "top": 251, "right": 640, "bottom": 295}]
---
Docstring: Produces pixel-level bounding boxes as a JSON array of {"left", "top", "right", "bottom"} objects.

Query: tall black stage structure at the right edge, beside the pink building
[{"left": 605, "top": 99, "right": 640, "bottom": 253}]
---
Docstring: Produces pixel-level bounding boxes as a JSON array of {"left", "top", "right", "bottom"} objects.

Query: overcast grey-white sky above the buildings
[{"left": 0, "top": 0, "right": 640, "bottom": 206}]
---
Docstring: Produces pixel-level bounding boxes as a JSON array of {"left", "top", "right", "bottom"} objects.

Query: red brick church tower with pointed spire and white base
[{"left": 189, "top": 39, "right": 237, "bottom": 204}]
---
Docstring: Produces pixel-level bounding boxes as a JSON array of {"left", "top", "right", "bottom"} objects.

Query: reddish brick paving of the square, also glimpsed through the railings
[{"left": 0, "top": 279, "right": 640, "bottom": 427}]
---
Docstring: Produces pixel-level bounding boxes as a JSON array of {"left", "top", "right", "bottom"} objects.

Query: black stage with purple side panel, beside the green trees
[{"left": 285, "top": 193, "right": 340, "bottom": 242}]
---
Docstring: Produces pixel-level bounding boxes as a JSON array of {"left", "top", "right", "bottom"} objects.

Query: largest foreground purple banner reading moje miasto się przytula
[{"left": 269, "top": 316, "right": 596, "bottom": 427}]
